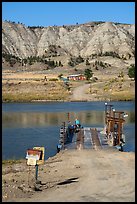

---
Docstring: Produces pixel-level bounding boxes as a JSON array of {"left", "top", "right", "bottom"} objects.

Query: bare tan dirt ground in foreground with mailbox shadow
[{"left": 2, "top": 148, "right": 135, "bottom": 202}]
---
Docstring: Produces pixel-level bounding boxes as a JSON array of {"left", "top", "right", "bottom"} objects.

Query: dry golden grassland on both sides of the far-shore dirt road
[{"left": 2, "top": 70, "right": 135, "bottom": 102}]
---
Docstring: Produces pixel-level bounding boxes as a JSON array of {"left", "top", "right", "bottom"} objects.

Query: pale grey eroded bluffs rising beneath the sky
[{"left": 2, "top": 21, "right": 135, "bottom": 60}]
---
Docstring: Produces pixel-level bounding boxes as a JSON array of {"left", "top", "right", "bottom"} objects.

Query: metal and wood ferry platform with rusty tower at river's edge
[{"left": 57, "top": 103, "right": 127, "bottom": 151}]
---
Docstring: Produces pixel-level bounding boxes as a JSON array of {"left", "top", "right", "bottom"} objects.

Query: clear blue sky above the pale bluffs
[{"left": 2, "top": 2, "right": 135, "bottom": 27}]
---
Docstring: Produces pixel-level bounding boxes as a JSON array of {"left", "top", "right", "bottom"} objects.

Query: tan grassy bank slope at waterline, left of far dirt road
[{"left": 2, "top": 81, "right": 69, "bottom": 102}]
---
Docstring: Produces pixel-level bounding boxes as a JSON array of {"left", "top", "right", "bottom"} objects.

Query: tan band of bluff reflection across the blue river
[{"left": 2, "top": 111, "right": 135, "bottom": 128}]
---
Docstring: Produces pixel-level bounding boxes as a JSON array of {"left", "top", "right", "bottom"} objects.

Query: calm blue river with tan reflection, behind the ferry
[{"left": 2, "top": 101, "right": 135, "bottom": 160}]
